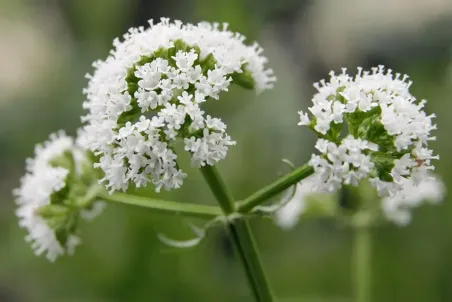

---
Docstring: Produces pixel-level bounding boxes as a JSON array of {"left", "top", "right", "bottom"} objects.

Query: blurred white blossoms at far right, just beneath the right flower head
[{"left": 382, "top": 177, "right": 445, "bottom": 226}]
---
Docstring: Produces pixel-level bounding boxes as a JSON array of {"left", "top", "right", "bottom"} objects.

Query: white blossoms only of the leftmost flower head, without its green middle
[{"left": 13, "top": 132, "right": 100, "bottom": 262}]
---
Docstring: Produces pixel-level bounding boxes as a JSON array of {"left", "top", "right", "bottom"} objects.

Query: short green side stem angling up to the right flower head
[{"left": 237, "top": 164, "right": 314, "bottom": 213}]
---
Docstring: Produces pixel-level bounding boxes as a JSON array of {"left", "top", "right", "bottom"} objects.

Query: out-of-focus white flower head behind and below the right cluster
[{"left": 274, "top": 174, "right": 446, "bottom": 230}]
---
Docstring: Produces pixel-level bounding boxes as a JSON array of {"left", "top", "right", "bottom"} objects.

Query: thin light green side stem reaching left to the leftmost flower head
[{"left": 97, "top": 191, "right": 223, "bottom": 219}]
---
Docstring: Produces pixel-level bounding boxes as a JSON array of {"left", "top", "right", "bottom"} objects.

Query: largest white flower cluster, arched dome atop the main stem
[{"left": 81, "top": 19, "right": 275, "bottom": 192}]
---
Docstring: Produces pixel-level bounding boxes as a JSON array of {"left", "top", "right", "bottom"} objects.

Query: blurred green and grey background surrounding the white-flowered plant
[{"left": 0, "top": 0, "right": 452, "bottom": 302}]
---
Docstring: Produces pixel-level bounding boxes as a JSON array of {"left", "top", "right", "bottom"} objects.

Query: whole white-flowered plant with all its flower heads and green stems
[{"left": 14, "top": 18, "right": 443, "bottom": 301}]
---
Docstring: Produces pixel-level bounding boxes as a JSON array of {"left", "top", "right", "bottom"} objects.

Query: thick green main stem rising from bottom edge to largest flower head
[{"left": 201, "top": 166, "right": 274, "bottom": 302}]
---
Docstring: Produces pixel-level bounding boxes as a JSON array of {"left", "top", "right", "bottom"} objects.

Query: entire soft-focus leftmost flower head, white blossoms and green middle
[{"left": 13, "top": 132, "right": 104, "bottom": 262}]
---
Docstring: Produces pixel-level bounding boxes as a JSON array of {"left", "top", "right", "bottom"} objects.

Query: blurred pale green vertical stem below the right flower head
[{"left": 353, "top": 225, "right": 372, "bottom": 302}]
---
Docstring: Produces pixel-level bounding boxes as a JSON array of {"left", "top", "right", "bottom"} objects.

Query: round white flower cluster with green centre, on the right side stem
[{"left": 299, "top": 66, "right": 438, "bottom": 196}]
